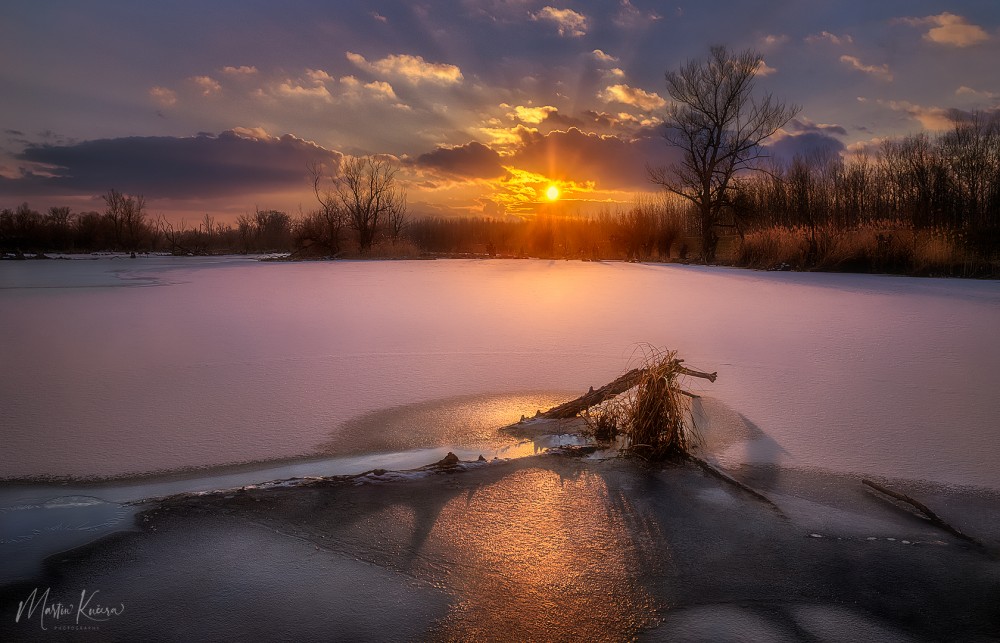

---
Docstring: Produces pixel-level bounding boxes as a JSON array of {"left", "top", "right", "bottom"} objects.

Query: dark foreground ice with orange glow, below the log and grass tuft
[{"left": 0, "top": 455, "right": 1000, "bottom": 640}]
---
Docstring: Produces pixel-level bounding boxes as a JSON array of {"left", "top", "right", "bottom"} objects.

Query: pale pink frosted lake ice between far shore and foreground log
[{"left": 0, "top": 257, "right": 1000, "bottom": 489}]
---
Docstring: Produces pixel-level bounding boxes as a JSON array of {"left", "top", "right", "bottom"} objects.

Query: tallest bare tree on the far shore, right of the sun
[{"left": 649, "top": 47, "right": 799, "bottom": 262}]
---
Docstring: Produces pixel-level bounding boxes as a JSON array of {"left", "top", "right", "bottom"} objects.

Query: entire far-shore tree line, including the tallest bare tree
[{"left": 0, "top": 47, "right": 1000, "bottom": 276}]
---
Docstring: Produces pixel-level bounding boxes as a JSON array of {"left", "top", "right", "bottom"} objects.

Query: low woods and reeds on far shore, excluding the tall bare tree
[{"left": 0, "top": 114, "right": 1000, "bottom": 277}]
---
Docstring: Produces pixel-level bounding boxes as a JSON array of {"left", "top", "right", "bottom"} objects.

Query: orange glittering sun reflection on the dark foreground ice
[{"left": 427, "top": 469, "right": 664, "bottom": 640}]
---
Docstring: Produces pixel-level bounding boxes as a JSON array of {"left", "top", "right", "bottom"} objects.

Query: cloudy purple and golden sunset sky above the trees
[{"left": 0, "top": 0, "right": 1000, "bottom": 221}]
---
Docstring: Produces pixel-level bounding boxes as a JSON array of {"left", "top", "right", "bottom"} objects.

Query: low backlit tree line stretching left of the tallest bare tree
[{"left": 0, "top": 190, "right": 689, "bottom": 260}]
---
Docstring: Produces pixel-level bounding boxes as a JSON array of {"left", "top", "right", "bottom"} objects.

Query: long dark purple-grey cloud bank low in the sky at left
[{"left": 0, "top": 130, "right": 341, "bottom": 198}]
